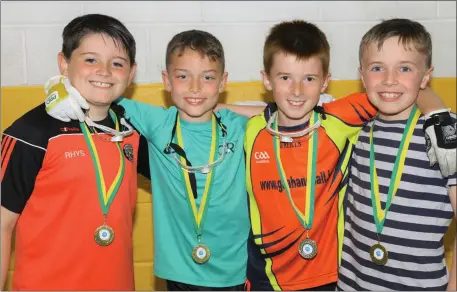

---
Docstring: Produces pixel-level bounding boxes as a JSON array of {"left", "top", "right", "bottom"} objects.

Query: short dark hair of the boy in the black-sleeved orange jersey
[{"left": 62, "top": 14, "right": 136, "bottom": 65}]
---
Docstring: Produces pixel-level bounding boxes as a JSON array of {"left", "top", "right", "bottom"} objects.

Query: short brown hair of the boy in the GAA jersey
[{"left": 263, "top": 20, "right": 330, "bottom": 74}]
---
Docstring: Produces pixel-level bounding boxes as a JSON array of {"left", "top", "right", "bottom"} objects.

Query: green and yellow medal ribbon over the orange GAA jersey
[{"left": 273, "top": 111, "right": 318, "bottom": 230}]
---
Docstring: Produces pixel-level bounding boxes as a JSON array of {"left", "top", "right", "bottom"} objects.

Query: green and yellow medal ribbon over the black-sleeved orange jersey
[{"left": 79, "top": 110, "right": 125, "bottom": 216}]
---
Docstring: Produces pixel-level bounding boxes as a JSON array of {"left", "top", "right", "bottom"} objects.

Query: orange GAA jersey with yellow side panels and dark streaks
[{"left": 245, "top": 94, "right": 376, "bottom": 290}]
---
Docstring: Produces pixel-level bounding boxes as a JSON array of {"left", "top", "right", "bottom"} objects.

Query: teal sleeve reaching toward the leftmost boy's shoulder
[{"left": 116, "top": 97, "right": 176, "bottom": 140}]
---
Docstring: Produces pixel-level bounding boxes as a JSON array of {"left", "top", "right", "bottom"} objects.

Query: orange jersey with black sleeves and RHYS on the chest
[{"left": 1, "top": 104, "right": 149, "bottom": 290}]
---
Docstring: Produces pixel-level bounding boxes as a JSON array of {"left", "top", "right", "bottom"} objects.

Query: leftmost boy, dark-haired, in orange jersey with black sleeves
[{"left": 1, "top": 14, "right": 148, "bottom": 291}]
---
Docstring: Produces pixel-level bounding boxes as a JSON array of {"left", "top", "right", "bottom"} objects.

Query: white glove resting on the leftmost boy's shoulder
[{"left": 44, "top": 75, "right": 89, "bottom": 122}]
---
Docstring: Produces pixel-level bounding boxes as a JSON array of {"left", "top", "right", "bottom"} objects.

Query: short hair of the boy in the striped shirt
[{"left": 359, "top": 18, "right": 432, "bottom": 68}]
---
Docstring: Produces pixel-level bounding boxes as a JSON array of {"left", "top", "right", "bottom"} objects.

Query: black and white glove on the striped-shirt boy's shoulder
[{"left": 423, "top": 110, "right": 457, "bottom": 177}]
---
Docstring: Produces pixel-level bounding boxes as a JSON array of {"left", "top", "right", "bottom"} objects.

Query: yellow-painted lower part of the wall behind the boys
[{"left": 1, "top": 78, "right": 456, "bottom": 290}]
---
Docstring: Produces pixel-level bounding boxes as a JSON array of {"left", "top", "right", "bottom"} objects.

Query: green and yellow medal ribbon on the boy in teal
[{"left": 176, "top": 115, "right": 219, "bottom": 238}]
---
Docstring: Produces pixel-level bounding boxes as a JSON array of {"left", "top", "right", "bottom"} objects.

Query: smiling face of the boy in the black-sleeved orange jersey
[{"left": 58, "top": 34, "right": 136, "bottom": 108}]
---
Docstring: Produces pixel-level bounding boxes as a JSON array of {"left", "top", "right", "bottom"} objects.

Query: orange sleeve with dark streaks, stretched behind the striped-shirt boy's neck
[{"left": 322, "top": 93, "right": 377, "bottom": 127}]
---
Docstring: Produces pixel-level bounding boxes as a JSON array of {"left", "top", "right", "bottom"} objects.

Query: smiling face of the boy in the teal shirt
[{"left": 162, "top": 49, "right": 227, "bottom": 122}]
